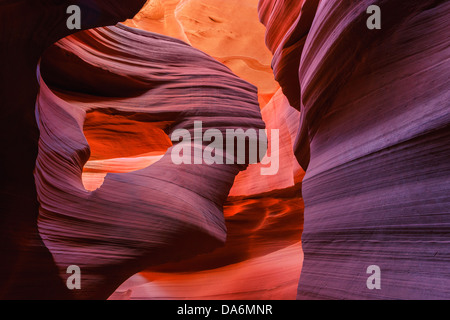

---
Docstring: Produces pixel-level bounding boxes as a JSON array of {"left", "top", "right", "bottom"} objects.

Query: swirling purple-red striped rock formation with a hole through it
[{"left": 36, "top": 25, "right": 265, "bottom": 298}]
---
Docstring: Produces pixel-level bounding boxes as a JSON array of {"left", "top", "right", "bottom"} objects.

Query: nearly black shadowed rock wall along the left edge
[{"left": 0, "top": 0, "right": 145, "bottom": 299}]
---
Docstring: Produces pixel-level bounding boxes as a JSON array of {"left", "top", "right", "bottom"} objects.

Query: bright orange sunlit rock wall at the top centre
[{"left": 125, "top": 0, "right": 279, "bottom": 107}]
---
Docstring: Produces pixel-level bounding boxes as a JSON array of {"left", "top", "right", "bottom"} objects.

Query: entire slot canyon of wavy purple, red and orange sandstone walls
[{"left": 0, "top": 0, "right": 450, "bottom": 300}]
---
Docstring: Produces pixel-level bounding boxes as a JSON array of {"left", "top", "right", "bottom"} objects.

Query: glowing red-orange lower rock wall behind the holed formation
[{"left": 111, "top": 90, "right": 304, "bottom": 300}]
